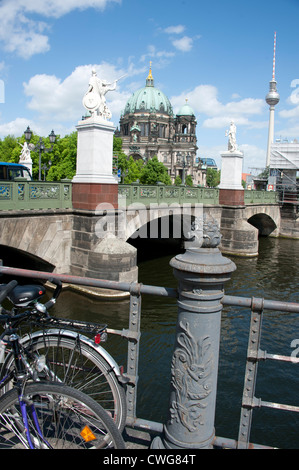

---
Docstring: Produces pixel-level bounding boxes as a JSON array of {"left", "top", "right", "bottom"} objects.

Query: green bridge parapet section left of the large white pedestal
[{"left": 0, "top": 178, "right": 72, "bottom": 211}]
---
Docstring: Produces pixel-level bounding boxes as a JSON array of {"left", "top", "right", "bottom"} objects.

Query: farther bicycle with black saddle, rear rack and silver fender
[{"left": 0, "top": 279, "right": 127, "bottom": 432}]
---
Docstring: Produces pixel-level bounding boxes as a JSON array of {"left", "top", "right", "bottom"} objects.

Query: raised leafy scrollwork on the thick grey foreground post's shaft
[{"left": 170, "top": 322, "right": 212, "bottom": 432}]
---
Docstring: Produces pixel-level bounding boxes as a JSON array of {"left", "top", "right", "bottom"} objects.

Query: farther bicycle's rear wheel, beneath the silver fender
[{"left": 2, "top": 331, "right": 127, "bottom": 431}]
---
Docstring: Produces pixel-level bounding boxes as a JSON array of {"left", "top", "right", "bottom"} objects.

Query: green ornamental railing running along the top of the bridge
[{"left": 0, "top": 178, "right": 279, "bottom": 211}]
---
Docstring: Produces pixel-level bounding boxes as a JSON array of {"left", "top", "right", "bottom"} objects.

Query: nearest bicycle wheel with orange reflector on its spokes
[{"left": 0, "top": 382, "right": 125, "bottom": 449}]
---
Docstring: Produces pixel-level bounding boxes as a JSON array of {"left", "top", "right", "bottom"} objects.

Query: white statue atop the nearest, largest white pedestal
[{"left": 83, "top": 69, "right": 122, "bottom": 120}]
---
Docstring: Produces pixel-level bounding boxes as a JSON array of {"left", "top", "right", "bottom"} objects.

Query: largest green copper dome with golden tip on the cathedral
[{"left": 123, "top": 69, "right": 173, "bottom": 116}]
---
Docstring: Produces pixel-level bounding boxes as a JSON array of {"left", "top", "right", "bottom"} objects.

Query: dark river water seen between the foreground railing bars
[{"left": 51, "top": 238, "right": 299, "bottom": 448}]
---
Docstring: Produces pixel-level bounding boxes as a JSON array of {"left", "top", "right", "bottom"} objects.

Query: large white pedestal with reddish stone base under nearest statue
[{"left": 73, "top": 115, "right": 118, "bottom": 210}]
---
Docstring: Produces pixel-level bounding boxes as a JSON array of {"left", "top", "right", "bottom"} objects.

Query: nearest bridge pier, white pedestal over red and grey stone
[{"left": 71, "top": 113, "right": 138, "bottom": 297}]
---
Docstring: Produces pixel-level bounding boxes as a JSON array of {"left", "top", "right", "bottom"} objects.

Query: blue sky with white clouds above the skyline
[{"left": 0, "top": 0, "right": 299, "bottom": 172}]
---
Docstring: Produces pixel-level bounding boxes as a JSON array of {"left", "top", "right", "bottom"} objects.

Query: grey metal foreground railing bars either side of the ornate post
[{"left": 0, "top": 266, "right": 299, "bottom": 448}]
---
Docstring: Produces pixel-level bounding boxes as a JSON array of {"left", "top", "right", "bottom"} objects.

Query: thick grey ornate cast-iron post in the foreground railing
[{"left": 152, "top": 219, "right": 236, "bottom": 449}]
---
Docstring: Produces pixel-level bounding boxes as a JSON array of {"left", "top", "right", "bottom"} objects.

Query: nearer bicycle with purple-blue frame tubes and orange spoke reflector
[{"left": 0, "top": 281, "right": 125, "bottom": 449}]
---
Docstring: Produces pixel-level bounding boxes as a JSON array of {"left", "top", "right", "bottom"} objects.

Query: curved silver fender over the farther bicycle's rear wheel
[{"left": 20, "top": 329, "right": 123, "bottom": 382}]
